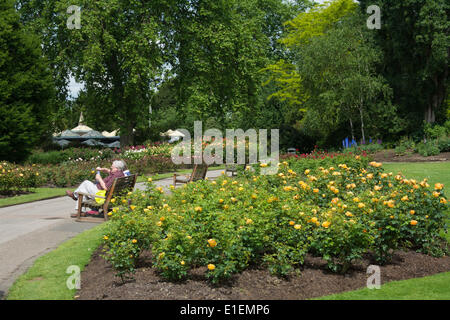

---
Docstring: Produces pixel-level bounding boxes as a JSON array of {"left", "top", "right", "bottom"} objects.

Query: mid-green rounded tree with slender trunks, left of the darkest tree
[{"left": 299, "top": 13, "right": 395, "bottom": 141}]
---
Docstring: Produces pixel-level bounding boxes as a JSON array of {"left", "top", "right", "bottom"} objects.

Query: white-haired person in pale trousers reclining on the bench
[{"left": 66, "top": 160, "right": 126, "bottom": 217}]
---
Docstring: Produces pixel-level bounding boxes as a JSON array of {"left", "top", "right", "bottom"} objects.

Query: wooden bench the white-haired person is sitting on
[{"left": 75, "top": 174, "right": 137, "bottom": 222}]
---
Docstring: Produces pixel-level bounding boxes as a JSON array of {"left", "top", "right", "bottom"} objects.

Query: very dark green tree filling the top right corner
[{"left": 359, "top": 0, "right": 450, "bottom": 127}]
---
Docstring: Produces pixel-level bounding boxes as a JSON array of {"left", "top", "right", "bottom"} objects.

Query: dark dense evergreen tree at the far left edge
[{"left": 0, "top": 0, "right": 54, "bottom": 161}]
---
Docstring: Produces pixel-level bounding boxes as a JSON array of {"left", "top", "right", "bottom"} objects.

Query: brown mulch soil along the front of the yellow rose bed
[{"left": 77, "top": 250, "right": 450, "bottom": 300}]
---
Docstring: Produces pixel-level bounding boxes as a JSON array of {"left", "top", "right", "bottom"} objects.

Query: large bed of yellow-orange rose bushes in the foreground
[{"left": 100, "top": 156, "right": 447, "bottom": 283}]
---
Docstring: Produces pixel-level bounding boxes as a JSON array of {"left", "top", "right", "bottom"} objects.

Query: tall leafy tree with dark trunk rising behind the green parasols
[{"left": 19, "top": 0, "right": 166, "bottom": 146}]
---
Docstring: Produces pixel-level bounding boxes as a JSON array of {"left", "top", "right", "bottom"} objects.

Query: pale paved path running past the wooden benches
[{"left": 0, "top": 170, "right": 223, "bottom": 299}]
